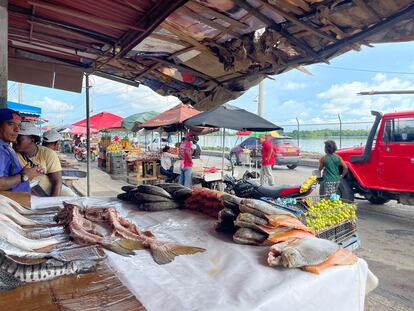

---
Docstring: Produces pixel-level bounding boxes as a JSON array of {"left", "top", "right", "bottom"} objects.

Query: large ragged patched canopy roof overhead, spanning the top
[{"left": 8, "top": 0, "right": 414, "bottom": 110}]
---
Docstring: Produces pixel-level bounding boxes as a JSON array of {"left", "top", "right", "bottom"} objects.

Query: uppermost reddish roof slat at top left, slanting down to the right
[{"left": 28, "top": 0, "right": 145, "bottom": 31}]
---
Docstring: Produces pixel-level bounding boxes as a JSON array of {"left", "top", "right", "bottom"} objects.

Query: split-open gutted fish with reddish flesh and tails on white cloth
[{"left": 56, "top": 203, "right": 204, "bottom": 264}]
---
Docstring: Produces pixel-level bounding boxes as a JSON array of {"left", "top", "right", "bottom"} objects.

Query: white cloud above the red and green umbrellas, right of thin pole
[{"left": 92, "top": 76, "right": 180, "bottom": 114}]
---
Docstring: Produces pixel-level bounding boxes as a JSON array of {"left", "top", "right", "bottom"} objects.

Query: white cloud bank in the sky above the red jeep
[{"left": 317, "top": 74, "right": 414, "bottom": 120}]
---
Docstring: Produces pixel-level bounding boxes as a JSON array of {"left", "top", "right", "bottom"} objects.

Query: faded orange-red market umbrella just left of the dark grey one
[{"left": 138, "top": 103, "right": 200, "bottom": 129}]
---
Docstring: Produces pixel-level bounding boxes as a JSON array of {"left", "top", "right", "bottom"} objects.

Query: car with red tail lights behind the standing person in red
[{"left": 230, "top": 136, "right": 300, "bottom": 170}]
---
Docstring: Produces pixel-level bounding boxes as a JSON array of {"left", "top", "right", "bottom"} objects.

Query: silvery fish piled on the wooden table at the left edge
[{"left": 0, "top": 195, "right": 105, "bottom": 291}]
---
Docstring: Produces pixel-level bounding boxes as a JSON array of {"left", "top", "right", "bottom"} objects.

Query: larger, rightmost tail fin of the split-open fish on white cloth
[{"left": 150, "top": 242, "right": 205, "bottom": 265}]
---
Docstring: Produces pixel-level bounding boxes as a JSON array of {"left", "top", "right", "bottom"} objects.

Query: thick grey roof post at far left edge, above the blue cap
[{"left": 0, "top": 0, "right": 9, "bottom": 108}]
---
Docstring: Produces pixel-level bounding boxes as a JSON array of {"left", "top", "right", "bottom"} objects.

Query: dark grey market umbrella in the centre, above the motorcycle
[{"left": 184, "top": 104, "right": 282, "bottom": 132}]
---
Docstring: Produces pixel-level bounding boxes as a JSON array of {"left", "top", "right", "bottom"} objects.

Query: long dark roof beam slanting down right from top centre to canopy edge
[{"left": 233, "top": 0, "right": 329, "bottom": 64}]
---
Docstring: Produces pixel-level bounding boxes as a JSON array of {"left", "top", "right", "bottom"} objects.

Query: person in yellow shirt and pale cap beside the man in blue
[{"left": 14, "top": 122, "right": 62, "bottom": 197}]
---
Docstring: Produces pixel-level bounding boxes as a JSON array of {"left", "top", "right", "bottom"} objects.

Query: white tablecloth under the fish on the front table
[{"left": 32, "top": 198, "right": 368, "bottom": 311}]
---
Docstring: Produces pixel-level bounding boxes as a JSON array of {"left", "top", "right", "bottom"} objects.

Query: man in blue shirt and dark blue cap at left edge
[{"left": 0, "top": 108, "right": 43, "bottom": 192}]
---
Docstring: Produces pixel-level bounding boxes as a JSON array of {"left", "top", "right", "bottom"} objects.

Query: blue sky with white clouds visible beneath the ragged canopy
[{"left": 8, "top": 42, "right": 414, "bottom": 129}]
